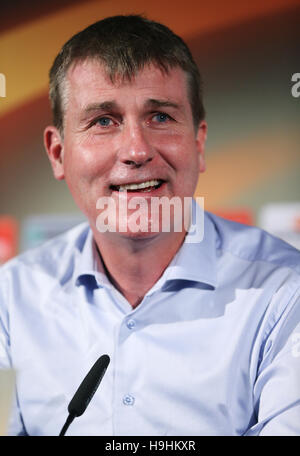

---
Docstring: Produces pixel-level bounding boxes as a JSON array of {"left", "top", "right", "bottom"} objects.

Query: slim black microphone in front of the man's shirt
[{"left": 59, "top": 355, "right": 110, "bottom": 436}]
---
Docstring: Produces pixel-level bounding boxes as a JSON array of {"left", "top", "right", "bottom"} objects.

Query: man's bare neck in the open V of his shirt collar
[{"left": 93, "top": 230, "right": 186, "bottom": 308}]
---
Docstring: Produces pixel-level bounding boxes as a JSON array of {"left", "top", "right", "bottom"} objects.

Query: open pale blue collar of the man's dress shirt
[{"left": 74, "top": 200, "right": 217, "bottom": 291}]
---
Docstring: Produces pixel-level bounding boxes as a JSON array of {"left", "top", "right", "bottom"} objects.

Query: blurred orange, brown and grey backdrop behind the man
[{"left": 0, "top": 0, "right": 300, "bottom": 262}]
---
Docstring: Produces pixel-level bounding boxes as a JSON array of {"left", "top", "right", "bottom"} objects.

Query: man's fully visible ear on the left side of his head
[{"left": 44, "top": 126, "right": 65, "bottom": 180}]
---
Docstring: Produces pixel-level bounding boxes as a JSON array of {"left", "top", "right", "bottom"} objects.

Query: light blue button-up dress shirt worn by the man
[{"left": 0, "top": 206, "right": 300, "bottom": 436}]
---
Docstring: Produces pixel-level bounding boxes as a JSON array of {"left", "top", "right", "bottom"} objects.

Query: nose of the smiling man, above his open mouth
[{"left": 119, "top": 125, "right": 155, "bottom": 168}]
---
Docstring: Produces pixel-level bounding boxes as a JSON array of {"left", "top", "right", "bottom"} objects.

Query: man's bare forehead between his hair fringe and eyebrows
[{"left": 66, "top": 60, "right": 189, "bottom": 106}]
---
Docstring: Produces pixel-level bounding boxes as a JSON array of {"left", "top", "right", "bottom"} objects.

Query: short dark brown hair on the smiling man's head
[{"left": 49, "top": 15, "right": 205, "bottom": 133}]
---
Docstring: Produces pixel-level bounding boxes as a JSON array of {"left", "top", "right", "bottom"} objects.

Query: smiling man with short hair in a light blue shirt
[{"left": 0, "top": 16, "right": 300, "bottom": 435}]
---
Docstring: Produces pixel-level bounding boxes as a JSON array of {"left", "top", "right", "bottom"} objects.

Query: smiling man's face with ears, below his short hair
[{"left": 45, "top": 60, "right": 206, "bottom": 236}]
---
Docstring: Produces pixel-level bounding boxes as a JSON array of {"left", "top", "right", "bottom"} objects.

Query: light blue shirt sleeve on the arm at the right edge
[{"left": 245, "top": 289, "right": 300, "bottom": 436}]
